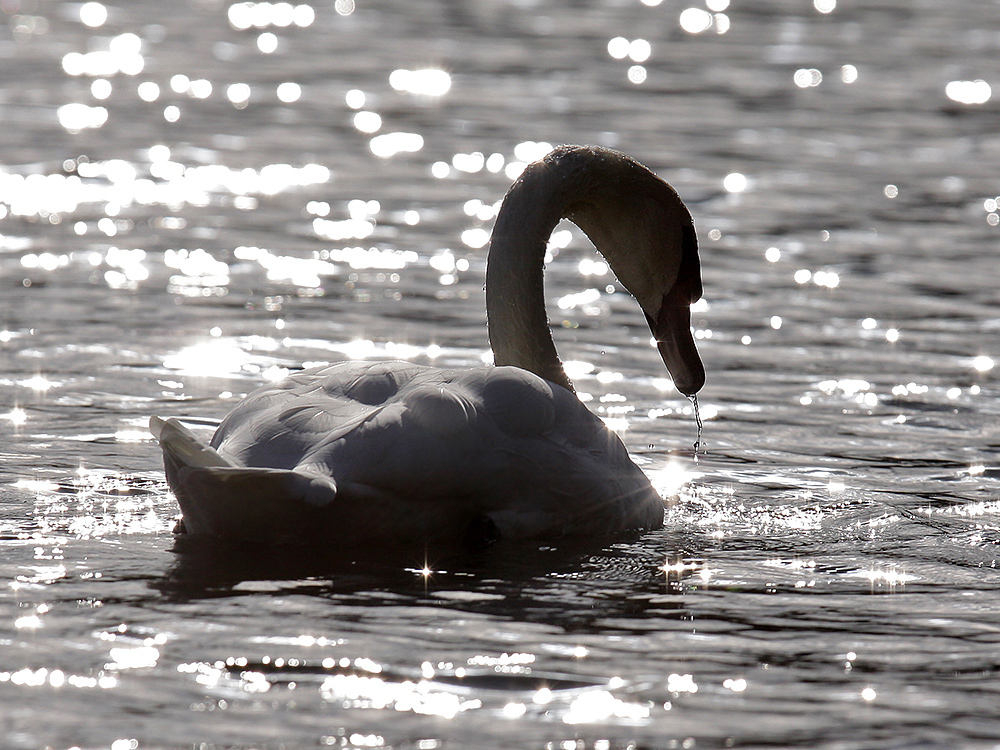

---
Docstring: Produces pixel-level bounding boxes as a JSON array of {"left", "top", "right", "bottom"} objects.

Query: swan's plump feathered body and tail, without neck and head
[{"left": 154, "top": 362, "right": 663, "bottom": 543}]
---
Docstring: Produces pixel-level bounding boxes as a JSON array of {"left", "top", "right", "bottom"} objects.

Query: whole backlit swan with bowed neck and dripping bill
[{"left": 150, "top": 146, "right": 705, "bottom": 548}]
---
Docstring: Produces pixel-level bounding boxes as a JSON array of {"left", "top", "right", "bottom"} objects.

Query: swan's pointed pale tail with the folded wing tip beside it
[{"left": 150, "top": 417, "right": 337, "bottom": 544}]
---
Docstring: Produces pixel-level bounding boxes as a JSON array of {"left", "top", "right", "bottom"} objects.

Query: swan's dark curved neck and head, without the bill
[{"left": 486, "top": 146, "right": 701, "bottom": 390}]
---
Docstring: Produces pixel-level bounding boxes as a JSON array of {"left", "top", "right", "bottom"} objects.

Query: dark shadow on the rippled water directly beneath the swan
[{"left": 150, "top": 531, "right": 704, "bottom": 631}]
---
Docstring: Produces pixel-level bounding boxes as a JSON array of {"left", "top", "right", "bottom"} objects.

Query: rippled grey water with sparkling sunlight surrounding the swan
[{"left": 0, "top": 0, "right": 1000, "bottom": 750}]
